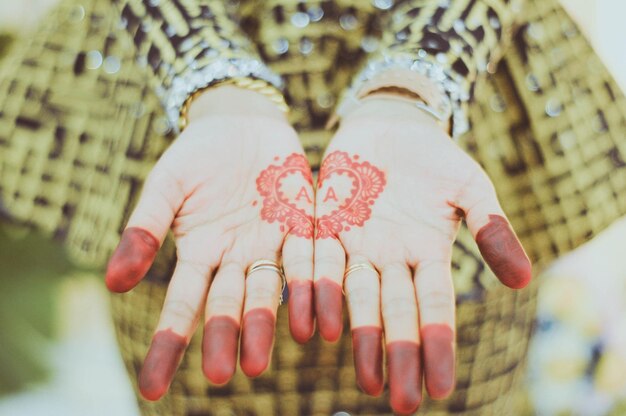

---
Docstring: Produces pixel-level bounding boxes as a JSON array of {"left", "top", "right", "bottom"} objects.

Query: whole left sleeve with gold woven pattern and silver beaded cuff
[{"left": 113, "top": 0, "right": 282, "bottom": 130}]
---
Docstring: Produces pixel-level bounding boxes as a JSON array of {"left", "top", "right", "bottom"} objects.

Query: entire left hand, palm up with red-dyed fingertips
[{"left": 106, "top": 86, "right": 314, "bottom": 400}]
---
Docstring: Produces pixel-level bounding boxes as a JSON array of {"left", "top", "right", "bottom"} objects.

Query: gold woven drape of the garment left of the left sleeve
[{"left": 0, "top": 1, "right": 171, "bottom": 265}]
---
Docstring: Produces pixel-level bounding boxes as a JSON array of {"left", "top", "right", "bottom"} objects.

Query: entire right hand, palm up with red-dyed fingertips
[{"left": 314, "top": 96, "right": 531, "bottom": 414}]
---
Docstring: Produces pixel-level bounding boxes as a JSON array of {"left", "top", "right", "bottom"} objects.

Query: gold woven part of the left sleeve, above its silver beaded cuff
[{"left": 109, "top": 0, "right": 257, "bottom": 96}]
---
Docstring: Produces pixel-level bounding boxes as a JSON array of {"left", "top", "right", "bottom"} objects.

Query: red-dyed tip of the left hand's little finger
[{"left": 288, "top": 280, "right": 315, "bottom": 344}]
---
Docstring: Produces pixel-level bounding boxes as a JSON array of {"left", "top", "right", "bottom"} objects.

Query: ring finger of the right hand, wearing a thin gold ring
[{"left": 344, "top": 259, "right": 383, "bottom": 396}]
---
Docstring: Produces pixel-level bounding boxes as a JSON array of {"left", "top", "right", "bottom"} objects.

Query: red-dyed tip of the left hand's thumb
[{"left": 105, "top": 227, "right": 159, "bottom": 293}]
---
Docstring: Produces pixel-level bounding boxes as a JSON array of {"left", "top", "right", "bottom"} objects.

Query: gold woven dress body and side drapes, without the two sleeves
[{"left": 0, "top": 0, "right": 626, "bottom": 415}]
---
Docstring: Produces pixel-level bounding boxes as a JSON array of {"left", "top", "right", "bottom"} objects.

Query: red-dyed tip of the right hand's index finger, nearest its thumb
[{"left": 420, "top": 324, "right": 455, "bottom": 399}]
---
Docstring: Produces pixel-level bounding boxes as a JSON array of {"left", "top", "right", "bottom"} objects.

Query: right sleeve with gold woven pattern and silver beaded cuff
[{"left": 344, "top": 0, "right": 523, "bottom": 136}]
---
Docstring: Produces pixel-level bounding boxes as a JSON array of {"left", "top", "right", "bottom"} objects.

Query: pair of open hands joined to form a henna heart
[{"left": 106, "top": 86, "right": 531, "bottom": 413}]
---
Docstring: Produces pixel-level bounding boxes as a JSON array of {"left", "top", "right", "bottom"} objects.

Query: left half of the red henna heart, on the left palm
[{"left": 253, "top": 153, "right": 313, "bottom": 239}]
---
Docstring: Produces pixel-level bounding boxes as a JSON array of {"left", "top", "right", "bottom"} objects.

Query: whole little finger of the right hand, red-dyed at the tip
[{"left": 313, "top": 238, "right": 346, "bottom": 342}]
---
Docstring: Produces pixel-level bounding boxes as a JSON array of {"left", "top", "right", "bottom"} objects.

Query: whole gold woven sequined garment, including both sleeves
[{"left": 0, "top": 0, "right": 626, "bottom": 415}]
